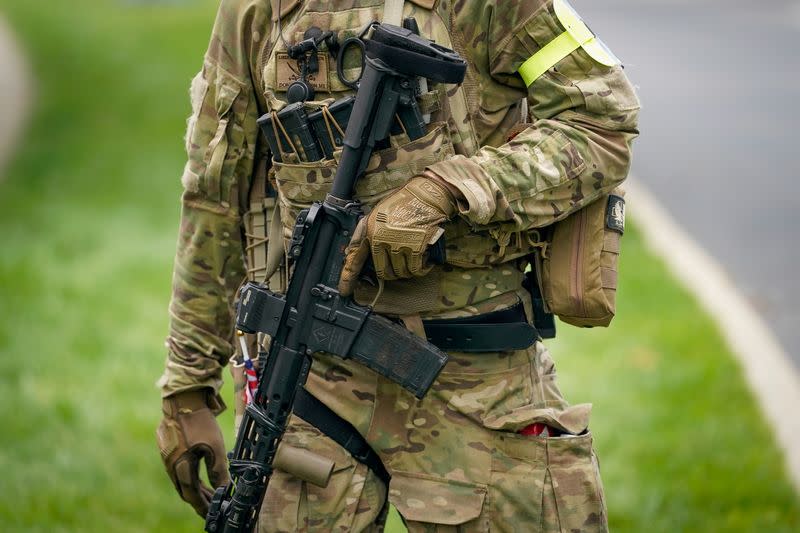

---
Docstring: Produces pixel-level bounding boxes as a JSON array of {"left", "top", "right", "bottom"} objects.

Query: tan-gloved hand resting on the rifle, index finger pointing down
[{"left": 339, "top": 172, "right": 456, "bottom": 296}]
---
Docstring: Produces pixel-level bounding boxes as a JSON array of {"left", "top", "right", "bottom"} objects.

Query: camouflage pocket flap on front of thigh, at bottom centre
[{"left": 389, "top": 472, "right": 486, "bottom": 526}]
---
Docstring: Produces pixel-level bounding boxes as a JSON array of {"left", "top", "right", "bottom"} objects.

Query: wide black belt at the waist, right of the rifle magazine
[{"left": 422, "top": 303, "right": 539, "bottom": 352}]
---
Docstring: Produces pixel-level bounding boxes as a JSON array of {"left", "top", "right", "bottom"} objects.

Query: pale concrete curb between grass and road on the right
[{"left": 626, "top": 178, "right": 800, "bottom": 491}]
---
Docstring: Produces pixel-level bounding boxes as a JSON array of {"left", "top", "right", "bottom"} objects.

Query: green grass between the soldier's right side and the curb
[{"left": 551, "top": 238, "right": 800, "bottom": 532}]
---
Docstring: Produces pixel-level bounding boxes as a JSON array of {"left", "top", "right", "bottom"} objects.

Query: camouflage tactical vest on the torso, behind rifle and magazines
[{"left": 245, "top": 0, "right": 538, "bottom": 316}]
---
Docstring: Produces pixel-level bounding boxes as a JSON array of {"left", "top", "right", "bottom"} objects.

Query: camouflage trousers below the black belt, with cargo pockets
[{"left": 238, "top": 332, "right": 607, "bottom": 532}]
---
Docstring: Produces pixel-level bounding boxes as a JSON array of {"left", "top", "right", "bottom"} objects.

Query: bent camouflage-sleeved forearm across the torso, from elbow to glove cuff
[{"left": 430, "top": 104, "right": 636, "bottom": 230}]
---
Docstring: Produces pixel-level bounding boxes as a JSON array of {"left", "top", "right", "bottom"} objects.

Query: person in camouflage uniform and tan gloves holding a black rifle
[{"left": 158, "top": 0, "right": 639, "bottom": 531}]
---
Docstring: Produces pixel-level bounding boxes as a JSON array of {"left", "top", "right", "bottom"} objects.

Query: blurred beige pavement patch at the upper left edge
[{"left": 0, "top": 14, "right": 33, "bottom": 180}]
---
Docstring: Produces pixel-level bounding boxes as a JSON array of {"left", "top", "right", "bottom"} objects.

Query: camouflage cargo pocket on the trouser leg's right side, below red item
[{"left": 489, "top": 432, "right": 608, "bottom": 533}]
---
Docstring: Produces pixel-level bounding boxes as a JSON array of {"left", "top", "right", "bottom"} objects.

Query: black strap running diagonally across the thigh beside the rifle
[{"left": 292, "top": 387, "right": 391, "bottom": 486}]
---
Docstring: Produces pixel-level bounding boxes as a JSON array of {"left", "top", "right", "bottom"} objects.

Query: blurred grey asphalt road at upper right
[{"left": 572, "top": 0, "right": 800, "bottom": 362}]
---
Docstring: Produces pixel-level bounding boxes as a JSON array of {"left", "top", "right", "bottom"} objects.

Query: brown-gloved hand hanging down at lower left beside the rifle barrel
[{"left": 156, "top": 389, "right": 228, "bottom": 518}]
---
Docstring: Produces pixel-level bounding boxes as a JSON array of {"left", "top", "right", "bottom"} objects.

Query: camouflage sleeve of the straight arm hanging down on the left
[{"left": 159, "top": 0, "right": 268, "bottom": 396}]
